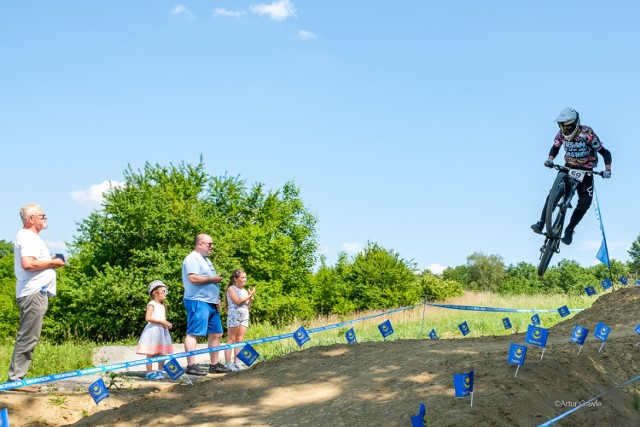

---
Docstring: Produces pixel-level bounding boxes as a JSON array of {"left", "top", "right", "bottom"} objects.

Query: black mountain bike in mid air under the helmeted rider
[{"left": 538, "top": 164, "right": 602, "bottom": 276}]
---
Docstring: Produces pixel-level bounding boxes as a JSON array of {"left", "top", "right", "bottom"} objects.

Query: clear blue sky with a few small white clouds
[{"left": 0, "top": 0, "right": 640, "bottom": 270}]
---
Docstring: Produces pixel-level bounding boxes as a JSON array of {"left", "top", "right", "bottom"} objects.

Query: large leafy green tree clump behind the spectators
[{"left": 52, "top": 160, "right": 317, "bottom": 340}]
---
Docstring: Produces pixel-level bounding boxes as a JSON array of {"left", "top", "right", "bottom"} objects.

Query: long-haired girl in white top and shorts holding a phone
[{"left": 224, "top": 269, "right": 256, "bottom": 371}]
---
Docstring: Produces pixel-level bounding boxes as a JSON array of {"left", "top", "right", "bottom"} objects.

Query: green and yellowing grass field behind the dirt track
[{"left": 0, "top": 292, "right": 596, "bottom": 382}]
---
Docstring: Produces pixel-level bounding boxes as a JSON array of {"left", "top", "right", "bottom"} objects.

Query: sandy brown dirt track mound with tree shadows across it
[{"left": 0, "top": 287, "right": 640, "bottom": 427}]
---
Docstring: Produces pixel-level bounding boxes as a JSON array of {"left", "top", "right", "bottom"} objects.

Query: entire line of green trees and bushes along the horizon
[{"left": 0, "top": 159, "right": 640, "bottom": 342}]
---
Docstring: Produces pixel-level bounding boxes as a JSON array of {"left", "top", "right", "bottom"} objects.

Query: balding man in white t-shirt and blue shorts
[{"left": 182, "top": 234, "right": 229, "bottom": 375}]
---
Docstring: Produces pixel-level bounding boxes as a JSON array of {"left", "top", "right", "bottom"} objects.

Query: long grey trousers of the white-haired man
[{"left": 9, "top": 292, "right": 49, "bottom": 381}]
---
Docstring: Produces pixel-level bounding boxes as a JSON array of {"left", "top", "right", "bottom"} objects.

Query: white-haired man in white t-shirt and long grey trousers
[{"left": 9, "top": 204, "right": 64, "bottom": 393}]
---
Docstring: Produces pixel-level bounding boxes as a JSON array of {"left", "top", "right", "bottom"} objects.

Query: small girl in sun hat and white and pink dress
[{"left": 136, "top": 280, "right": 173, "bottom": 380}]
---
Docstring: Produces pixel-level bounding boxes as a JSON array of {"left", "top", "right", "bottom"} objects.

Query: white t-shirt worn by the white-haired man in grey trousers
[{"left": 13, "top": 228, "right": 56, "bottom": 298}]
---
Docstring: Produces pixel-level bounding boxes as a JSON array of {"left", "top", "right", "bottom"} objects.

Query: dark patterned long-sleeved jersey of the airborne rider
[{"left": 549, "top": 126, "right": 607, "bottom": 170}]
